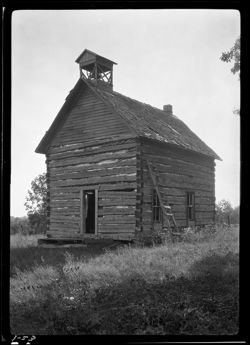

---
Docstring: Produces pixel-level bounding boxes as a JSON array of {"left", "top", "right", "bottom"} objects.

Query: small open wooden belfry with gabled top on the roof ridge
[{"left": 76, "top": 49, "right": 117, "bottom": 89}]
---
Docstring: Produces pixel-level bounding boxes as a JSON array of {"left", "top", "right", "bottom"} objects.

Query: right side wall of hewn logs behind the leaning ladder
[{"left": 138, "top": 139, "right": 215, "bottom": 232}]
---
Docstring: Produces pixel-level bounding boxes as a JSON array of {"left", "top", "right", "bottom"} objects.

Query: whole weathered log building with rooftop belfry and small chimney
[{"left": 36, "top": 49, "right": 220, "bottom": 240}]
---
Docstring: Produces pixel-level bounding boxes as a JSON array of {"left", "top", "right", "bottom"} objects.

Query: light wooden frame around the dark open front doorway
[{"left": 80, "top": 186, "right": 99, "bottom": 237}]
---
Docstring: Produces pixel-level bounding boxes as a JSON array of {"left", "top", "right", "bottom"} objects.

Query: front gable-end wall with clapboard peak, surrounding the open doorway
[{"left": 46, "top": 87, "right": 137, "bottom": 239}]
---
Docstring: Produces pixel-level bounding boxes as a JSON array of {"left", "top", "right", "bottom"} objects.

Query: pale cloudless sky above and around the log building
[{"left": 11, "top": 9, "right": 240, "bottom": 217}]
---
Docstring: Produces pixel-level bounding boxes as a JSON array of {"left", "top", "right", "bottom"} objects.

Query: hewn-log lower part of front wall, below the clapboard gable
[{"left": 47, "top": 138, "right": 137, "bottom": 237}]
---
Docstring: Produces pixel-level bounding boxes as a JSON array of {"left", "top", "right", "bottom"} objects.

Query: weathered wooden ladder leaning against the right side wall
[{"left": 147, "top": 160, "right": 179, "bottom": 235}]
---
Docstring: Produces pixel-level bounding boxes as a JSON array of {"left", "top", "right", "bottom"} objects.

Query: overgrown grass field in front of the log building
[{"left": 10, "top": 227, "right": 239, "bottom": 335}]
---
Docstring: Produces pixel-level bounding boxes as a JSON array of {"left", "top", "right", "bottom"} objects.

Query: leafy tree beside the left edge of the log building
[{"left": 24, "top": 173, "right": 48, "bottom": 233}]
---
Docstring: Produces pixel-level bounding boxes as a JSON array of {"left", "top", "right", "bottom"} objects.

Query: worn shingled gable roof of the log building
[{"left": 36, "top": 79, "right": 221, "bottom": 160}]
